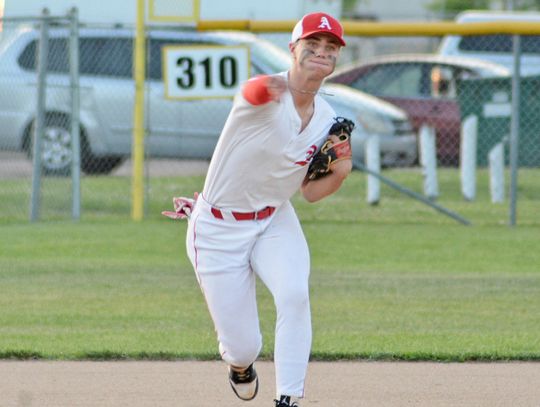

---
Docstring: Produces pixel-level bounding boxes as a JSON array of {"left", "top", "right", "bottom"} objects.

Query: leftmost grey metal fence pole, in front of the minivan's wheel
[{"left": 30, "top": 8, "right": 49, "bottom": 221}]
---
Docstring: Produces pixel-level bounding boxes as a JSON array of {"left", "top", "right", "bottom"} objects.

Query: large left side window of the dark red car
[{"left": 351, "top": 64, "right": 429, "bottom": 97}]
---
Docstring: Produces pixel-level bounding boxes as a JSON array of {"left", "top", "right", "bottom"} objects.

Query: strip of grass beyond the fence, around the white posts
[{"left": 0, "top": 168, "right": 540, "bottom": 227}]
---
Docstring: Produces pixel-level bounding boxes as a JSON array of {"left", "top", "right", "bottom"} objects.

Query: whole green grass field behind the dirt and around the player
[{"left": 0, "top": 171, "right": 540, "bottom": 361}]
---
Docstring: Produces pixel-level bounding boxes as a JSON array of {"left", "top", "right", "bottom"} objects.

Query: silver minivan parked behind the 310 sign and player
[{"left": 0, "top": 27, "right": 417, "bottom": 174}]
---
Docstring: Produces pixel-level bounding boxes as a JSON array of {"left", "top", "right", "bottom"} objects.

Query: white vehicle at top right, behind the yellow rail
[{"left": 438, "top": 11, "right": 540, "bottom": 75}]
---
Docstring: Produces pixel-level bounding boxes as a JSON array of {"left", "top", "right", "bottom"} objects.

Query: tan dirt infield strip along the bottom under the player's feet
[{"left": 0, "top": 361, "right": 540, "bottom": 407}]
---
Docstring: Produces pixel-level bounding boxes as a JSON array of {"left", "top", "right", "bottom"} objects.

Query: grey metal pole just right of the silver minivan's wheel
[{"left": 69, "top": 7, "right": 81, "bottom": 220}]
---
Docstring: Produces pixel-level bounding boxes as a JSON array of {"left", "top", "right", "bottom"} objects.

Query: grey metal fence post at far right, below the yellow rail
[{"left": 509, "top": 35, "right": 521, "bottom": 226}]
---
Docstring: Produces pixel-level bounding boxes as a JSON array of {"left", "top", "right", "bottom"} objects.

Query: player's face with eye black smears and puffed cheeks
[{"left": 293, "top": 34, "right": 341, "bottom": 77}]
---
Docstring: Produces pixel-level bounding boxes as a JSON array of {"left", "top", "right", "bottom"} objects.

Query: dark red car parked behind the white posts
[{"left": 328, "top": 54, "right": 510, "bottom": 165}]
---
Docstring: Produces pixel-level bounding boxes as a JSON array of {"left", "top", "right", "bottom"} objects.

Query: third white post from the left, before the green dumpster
[{"left": 460, "top": 115, "right": 478, "bottom": 201}]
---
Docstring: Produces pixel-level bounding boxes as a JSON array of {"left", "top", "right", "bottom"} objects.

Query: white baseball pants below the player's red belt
[{"left": 186, "top": 196, "right": 311, "bottom": 397}]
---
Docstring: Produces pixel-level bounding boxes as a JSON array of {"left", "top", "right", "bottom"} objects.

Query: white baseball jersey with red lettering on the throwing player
[{"left": 203, "top": 72, "right": 335, "bottom": 212}]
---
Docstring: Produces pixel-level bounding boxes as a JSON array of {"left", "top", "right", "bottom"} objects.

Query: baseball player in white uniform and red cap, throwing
[{"left": 165, "top": 13, "right": 352, "bottom": 407}]
